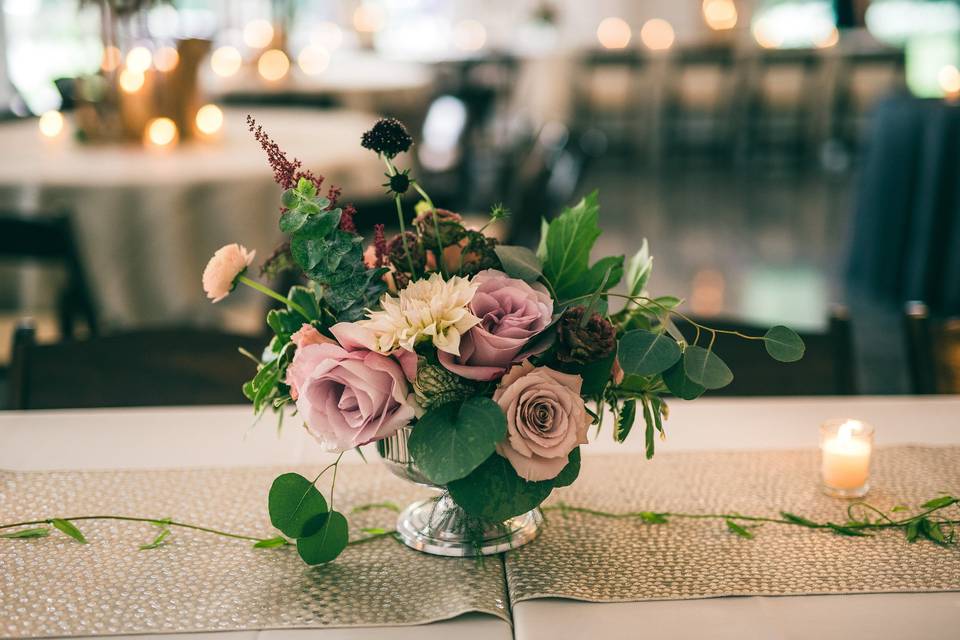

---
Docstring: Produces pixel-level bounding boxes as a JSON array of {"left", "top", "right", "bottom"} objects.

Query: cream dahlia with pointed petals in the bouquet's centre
[{"left": 357, "top": 273, "right": 480, "bottom": 356}]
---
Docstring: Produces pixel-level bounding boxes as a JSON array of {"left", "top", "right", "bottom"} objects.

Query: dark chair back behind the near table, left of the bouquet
[{"left": 7, "top": 321, "right": 267, "bottom": 409}]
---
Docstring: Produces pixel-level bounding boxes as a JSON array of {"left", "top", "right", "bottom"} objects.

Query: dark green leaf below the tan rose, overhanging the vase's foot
[{"left": 447, "top": 453, "right": 554, "bottom": 522}]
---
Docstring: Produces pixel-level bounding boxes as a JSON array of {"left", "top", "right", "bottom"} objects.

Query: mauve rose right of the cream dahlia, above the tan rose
[{"left": 438, "top": 269, "right": 553, "bottom": 380}]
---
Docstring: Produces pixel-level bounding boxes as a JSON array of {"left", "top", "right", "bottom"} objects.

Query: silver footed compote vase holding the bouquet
[{"left": 377, "top": 427, "right": 543, "bottom": 556}]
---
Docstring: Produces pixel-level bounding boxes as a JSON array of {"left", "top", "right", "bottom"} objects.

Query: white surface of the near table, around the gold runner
[{"left": 0, "top": 396, "right": 960, "bottom": 640}]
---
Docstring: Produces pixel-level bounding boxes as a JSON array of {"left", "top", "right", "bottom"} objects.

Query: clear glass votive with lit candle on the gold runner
[{"left": 820, "top": 419, "right": 873, "bottom": 498}]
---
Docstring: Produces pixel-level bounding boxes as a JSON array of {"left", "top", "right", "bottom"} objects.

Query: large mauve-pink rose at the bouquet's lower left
[{"left": 286, "top": 325, "right": 414, "bottom": 451}]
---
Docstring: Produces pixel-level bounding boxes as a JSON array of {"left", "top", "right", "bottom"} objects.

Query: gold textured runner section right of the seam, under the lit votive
[{"left": 506, "top": 446, "right": 960, "bottom": 602}]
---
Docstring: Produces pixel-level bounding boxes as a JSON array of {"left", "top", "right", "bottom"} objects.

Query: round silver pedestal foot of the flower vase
[{"left": 397, "top": 493, "right": 543, "bottom": 557}]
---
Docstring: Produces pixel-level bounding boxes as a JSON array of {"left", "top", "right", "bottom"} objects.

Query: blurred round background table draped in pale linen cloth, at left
[{"left": 0, "top": 107, "right": 383, "bottom": 330}]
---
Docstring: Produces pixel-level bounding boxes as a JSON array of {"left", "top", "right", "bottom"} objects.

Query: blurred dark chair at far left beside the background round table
[{"left": 0, "top": 211, "right": 98, "bottom": 338}]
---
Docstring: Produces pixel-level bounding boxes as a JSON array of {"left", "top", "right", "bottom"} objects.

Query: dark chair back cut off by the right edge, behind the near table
[{"left": 904, "top": 302, "right": 960, "bottom": 394}]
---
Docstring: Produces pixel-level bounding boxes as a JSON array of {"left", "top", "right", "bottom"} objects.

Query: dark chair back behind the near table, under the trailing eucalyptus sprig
[{"left": 677, "top": 306, "right": 857, "bottom": 396}]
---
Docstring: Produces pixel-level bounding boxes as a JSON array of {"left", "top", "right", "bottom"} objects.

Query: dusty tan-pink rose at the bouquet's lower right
[{"left": 493, "top": 361, "right": 590, "bottom": 480}]
